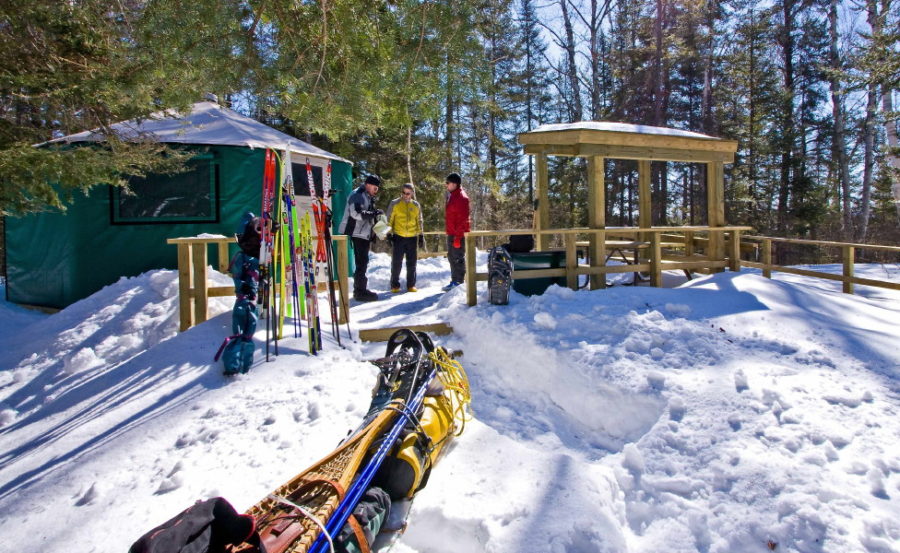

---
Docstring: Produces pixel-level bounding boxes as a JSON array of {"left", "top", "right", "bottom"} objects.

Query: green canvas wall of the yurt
[{"left": 5, "top": 146, "right": 352, "bottom": 308}]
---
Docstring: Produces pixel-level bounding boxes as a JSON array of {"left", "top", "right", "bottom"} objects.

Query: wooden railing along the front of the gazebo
[{"left": 465, "top": 226, "right": 752, "bottom": 305}]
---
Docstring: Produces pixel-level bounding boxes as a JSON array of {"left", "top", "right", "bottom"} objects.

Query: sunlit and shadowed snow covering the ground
[{"left": 0, "top": 252, "right": 900, "bottom": 553}]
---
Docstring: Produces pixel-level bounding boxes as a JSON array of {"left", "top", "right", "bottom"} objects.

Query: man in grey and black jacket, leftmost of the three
[{"left": 339, "top": 175, "right": 382, "bottom": 301}]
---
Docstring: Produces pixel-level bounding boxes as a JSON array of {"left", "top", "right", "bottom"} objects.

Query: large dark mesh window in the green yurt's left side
[{"left": 110, "top": 158, "right": 219, "bottom": 225}]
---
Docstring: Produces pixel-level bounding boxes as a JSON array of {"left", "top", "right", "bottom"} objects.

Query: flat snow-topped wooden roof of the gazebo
[{"left": 519, "top": 121, "right": 737, "bottom": 163}]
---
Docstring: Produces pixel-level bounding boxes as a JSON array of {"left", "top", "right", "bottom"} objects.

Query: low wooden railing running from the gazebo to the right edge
[{"left": 741, "top": 236, "right": 900, "bottom": 294}]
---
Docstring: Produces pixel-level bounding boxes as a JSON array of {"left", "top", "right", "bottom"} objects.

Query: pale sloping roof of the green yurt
[{"left": 48, "top": 102, "right": 350, "bottom": 163}]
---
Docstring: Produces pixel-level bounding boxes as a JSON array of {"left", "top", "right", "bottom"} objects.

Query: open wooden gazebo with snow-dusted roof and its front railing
[{"left": 460, "top": 121, "right": 749, "bottom": 304}]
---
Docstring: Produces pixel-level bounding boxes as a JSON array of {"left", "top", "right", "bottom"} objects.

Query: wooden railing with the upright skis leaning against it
[{"left": 166, "top": 234, "right": 350, "bottom": 332}]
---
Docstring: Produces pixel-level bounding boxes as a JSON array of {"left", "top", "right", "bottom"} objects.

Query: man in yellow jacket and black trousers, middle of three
[{"left": 387, "top": 183, "right": 425, "bottom": 294}]
